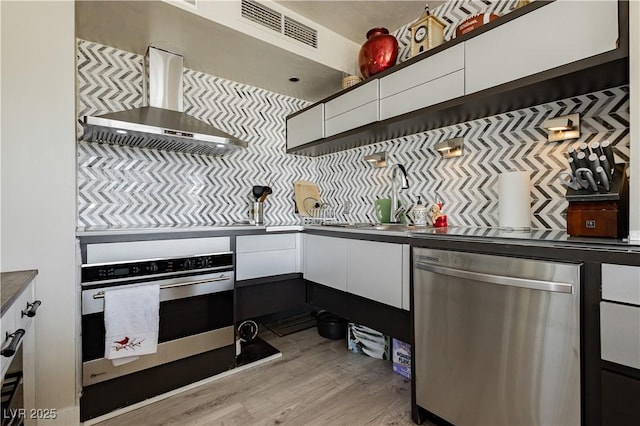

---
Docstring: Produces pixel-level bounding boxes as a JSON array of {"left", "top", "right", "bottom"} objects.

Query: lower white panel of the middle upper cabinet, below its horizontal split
[{"left": 380, "top": 70, "right": 464, "bottom": 120}]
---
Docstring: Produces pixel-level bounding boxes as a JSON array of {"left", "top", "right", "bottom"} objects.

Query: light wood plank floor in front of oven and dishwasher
[{"left": 92, "top": 328, "right": 414, "bottom": 426}]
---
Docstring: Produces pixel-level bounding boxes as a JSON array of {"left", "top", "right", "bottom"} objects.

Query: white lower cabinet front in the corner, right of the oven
[{"left": 236, "top": 234, "right": 302, "bottom": 280}]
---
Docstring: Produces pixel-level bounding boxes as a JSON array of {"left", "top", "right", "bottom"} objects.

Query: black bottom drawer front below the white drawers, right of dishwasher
[{"left": 602, "top": 363, "right": 640, "bottom": 426}]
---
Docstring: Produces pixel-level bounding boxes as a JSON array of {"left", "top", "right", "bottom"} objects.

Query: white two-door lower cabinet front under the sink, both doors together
[{"left": 304, "top": 234, "right": 409, "bottom": 310}]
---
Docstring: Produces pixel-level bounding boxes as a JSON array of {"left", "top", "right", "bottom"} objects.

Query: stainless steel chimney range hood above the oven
[{"left": 83, "top": 46, "right": 247, "bottom": 155}]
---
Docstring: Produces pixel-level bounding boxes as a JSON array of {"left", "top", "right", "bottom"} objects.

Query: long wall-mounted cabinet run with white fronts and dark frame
[{"left": 287, "top": 0, "right": 629, "bottom": 156}]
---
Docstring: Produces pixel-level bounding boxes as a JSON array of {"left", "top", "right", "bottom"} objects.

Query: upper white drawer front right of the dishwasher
[{"left": 602, "top": 264, "right": 640, "bottom": 306}]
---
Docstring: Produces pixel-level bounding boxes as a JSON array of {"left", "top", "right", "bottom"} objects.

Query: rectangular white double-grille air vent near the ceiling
[{"left": 241, "top": 0, "right": 318, "bottom": 49}]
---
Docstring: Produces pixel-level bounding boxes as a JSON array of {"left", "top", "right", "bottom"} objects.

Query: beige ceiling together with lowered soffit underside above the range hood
[{"left": 76, "top": 0, "right": 442, "bottom": 102}]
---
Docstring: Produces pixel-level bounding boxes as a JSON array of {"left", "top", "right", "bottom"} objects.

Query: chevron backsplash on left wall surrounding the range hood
[{"left": 78, "top": 40, "right": 315, "bottom": 226}]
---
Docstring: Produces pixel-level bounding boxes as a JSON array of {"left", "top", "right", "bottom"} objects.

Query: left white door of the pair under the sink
[{"left": 303, "top": 234, "right": 347, "bottom": 291}]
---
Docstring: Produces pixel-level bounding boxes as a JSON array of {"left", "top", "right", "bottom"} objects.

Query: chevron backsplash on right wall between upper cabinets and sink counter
[{"left": 317, "top": 86, "right": 629, "bottom": 229}]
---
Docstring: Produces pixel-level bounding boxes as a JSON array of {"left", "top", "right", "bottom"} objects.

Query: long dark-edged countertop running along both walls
[{"left": 77, "top": 222, "right": 640, "bottom": 264}]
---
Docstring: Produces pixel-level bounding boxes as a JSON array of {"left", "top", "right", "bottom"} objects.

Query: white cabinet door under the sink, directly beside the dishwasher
[{"left": 347, "top": 240, "right": 403, "bottom": 308}]
